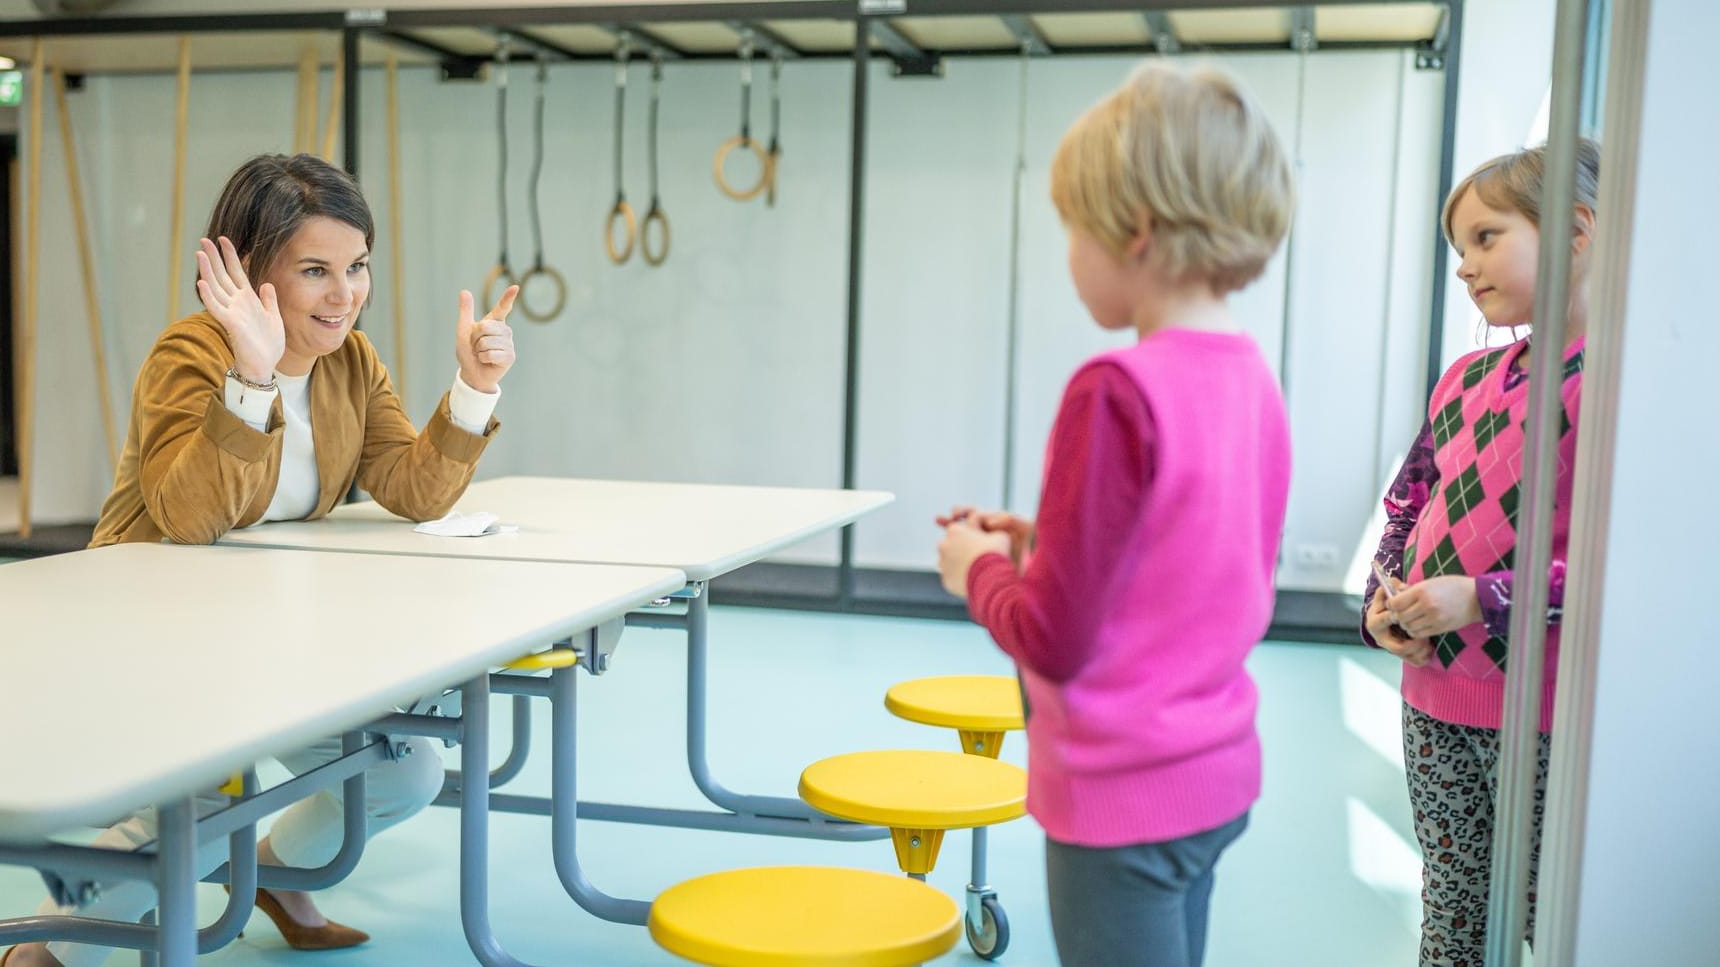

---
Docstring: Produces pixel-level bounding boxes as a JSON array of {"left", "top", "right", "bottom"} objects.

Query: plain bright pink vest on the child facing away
[{"left": 992, "top": 329, "right": 1290, "bottom": 847}]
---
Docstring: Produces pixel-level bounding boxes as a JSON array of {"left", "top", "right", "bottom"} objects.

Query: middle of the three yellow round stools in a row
[{"left": 800, "top": 748, "right": 1027, "bottom": 960}]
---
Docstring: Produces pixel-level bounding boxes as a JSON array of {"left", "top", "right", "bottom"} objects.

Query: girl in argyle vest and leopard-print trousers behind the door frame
[{"left": 1362, "top": 141, "right": 1600, "bottom": 967}]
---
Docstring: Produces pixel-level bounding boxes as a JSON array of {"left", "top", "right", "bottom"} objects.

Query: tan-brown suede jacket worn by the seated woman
[{"left": 89, "top": 313, "right": 501, "bottom": 547}]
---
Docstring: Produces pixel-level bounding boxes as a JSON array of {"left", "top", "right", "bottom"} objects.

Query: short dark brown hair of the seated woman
[{"left": 205, "top": 155, "right": 377, "bottom": 284}]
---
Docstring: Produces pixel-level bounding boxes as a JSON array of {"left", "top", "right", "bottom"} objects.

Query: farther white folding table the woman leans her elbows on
[{"left": 222, "top": 477, "right": 894, "bottom": 967}]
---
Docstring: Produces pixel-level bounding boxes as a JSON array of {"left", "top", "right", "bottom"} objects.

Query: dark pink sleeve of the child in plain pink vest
[{"left": 968, "top": 365, "right": 1154, "bottom": 681}]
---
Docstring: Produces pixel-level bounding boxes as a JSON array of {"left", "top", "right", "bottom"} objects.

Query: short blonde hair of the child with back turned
[{"left": 1051, "top": 62, "right": 1295, "bottom": 294}]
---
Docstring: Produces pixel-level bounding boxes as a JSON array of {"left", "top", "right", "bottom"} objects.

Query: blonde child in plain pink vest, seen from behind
[{"left": 939, "top": 62, "right": 1292, "bottom": 967}]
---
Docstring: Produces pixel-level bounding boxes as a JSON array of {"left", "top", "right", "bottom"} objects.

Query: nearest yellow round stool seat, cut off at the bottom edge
[{"left": 647, "top": 865, "right": 961, "bottom": 967}]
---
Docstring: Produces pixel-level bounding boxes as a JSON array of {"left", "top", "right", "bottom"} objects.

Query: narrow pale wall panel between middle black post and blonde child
[{"left": 855, "top": 60, "right": 1020, "bottom": 568}]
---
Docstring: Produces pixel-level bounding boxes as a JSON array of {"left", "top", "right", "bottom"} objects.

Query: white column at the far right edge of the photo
[{"left": 1536, "top": 0, "right": 1720, "bottom": 967}]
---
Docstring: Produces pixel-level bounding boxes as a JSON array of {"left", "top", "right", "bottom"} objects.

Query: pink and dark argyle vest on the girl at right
[{"left": 1404, "top": 339, "right": 1582, "bottom": 731}]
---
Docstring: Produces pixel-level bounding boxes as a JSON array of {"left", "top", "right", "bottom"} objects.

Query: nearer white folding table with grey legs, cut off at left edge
[{"left": 0, "top": 544, "right": 686, "bottom": 967}]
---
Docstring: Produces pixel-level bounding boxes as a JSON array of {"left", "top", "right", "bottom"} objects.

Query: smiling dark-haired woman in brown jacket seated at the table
[{"left": 0, "top": 155, "right": 518, "bottom": 967}]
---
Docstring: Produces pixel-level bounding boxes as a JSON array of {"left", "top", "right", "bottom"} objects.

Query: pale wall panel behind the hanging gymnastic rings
[{"left": 376, "top": 64, "right": 848, "bottom": 559}]
